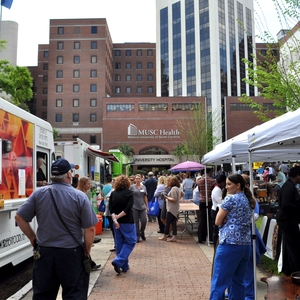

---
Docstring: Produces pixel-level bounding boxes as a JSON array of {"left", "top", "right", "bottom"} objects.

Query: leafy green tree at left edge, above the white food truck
[{"left": 0, "top": 60, "right": 33, "bottom": 111}]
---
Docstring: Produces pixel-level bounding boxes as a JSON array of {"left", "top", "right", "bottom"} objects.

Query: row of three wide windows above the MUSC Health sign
[{"left": 106, "top": 103, "right": 199, "bottom": 112}]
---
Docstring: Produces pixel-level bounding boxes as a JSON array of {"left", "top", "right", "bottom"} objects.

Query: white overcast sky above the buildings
[{"left": 2, "top": 0, "right": 288, "bottom": 66}]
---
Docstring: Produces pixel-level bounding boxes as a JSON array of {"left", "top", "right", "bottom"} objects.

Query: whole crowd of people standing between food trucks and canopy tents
[{"left": 15, "top": 158, "right": 300, "bottom": 300}]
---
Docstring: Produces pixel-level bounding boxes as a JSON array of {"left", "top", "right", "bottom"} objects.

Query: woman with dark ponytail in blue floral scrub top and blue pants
[{"left": 210, "top": 174, "right": 255, "bottom": 300}]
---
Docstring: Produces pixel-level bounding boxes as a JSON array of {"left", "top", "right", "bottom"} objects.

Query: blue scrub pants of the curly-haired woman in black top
[{"left": 113, "top": 223, "right": 136, "bottom": 272}]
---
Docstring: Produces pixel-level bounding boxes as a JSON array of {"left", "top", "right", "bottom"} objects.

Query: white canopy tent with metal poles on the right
[{"left": 202, "top": 109, "right": 300, "bottom": 299}]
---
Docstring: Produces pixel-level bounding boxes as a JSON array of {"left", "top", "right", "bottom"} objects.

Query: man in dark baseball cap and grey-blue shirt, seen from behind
[{"left": 15, "top": 158, "right": 98, "bottom": 300}]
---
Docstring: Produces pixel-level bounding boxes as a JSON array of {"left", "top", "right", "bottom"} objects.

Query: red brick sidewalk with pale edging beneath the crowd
[{"left": 9, "top": 220, "right": 267, "bottom": 300}]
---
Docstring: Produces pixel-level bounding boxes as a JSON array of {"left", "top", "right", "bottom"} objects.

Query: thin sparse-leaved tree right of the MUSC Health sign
[{"left": 173, "top": 103, "right": 220, "bottom": 162}]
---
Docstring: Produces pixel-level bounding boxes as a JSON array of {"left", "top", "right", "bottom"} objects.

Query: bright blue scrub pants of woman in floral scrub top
[{"left": 209, "top": 244, "right": 251, "bottom": 300}]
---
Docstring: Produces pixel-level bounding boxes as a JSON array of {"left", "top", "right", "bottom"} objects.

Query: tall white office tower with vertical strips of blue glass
[{"left": 156, "top": 0, "right": 256, "bottom": 140}]
